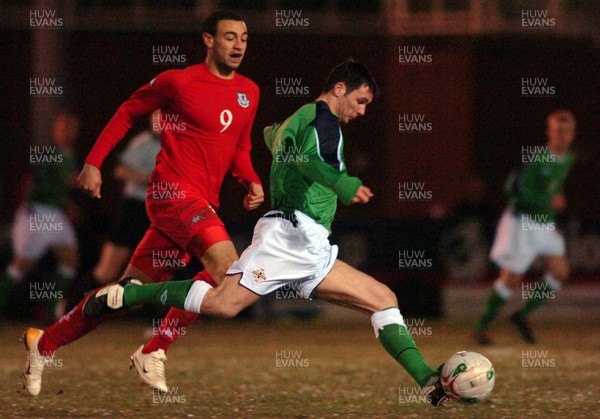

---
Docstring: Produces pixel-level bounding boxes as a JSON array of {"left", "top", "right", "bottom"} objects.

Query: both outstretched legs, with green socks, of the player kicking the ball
[{"left": 89, "top": 260, "right": 447, "bottom": 405}]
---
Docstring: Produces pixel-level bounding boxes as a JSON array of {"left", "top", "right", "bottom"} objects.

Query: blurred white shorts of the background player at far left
[{"left": 12, "top": 204, "right": 77, "bottom": 260}]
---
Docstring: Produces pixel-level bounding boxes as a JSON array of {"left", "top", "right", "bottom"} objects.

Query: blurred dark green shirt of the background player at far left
[{"left": 27, "top": 146, "right": 75, "bottom": 209}]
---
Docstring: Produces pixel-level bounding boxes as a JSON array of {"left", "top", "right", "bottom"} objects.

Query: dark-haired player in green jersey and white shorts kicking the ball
[{"left": 84, "top": 61, "right": 447, "bottom": 406}]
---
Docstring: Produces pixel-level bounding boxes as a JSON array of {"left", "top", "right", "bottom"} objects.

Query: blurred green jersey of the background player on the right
[{"left": 507, "top": 147, "right": 575, "bottom": 222}]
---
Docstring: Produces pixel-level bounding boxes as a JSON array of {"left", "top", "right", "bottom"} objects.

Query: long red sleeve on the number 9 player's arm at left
[{"left": 85, "top": 70, "right": 176, "bottom": 169}]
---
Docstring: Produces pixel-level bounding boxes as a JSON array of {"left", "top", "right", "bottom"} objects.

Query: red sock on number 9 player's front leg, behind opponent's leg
[{"left": 142, "top": 270, "right": 216, "bottom": 354}]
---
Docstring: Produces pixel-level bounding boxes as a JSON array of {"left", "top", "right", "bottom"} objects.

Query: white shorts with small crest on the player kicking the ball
[{"left": 227, "top": 211, "right": 338, "bottom": 299}]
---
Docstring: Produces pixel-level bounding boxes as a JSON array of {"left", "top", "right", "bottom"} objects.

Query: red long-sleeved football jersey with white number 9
[{"left": 86, "top": 64, "right": 260, "bottom": 208}]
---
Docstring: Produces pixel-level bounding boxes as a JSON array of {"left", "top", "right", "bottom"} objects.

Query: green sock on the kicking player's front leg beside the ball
[{"left": 379, "top": 324, "right": 438, "bottom": 387}]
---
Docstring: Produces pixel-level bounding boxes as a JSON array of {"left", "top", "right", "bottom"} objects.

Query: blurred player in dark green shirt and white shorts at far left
[{"left": 0, "top": 112, "right": 79, "bottom": 319}]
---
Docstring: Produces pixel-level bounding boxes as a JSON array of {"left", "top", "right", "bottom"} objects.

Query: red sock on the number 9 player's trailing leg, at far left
[{"left": 38, "top": 290, "right": 105, "bottom": 355}]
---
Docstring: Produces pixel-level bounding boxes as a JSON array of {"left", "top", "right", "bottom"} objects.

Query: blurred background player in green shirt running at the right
[{"left": 473, "top": 110, "right": 576, "bottom": 345}]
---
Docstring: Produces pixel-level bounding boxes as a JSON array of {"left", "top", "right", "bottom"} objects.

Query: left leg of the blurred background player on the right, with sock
[{"left": 473, "top": 268, "right": 523, "bottom": 345}]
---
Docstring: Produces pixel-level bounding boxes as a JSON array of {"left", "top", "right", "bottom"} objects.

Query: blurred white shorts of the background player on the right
[{"left": 490, "top": 208, "right": 565, "bottom": 274}]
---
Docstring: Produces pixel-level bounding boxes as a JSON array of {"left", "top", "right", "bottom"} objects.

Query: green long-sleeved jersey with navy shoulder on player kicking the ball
[{"left": 264, "top": 101, "right": 362, "bottom": 232}]
